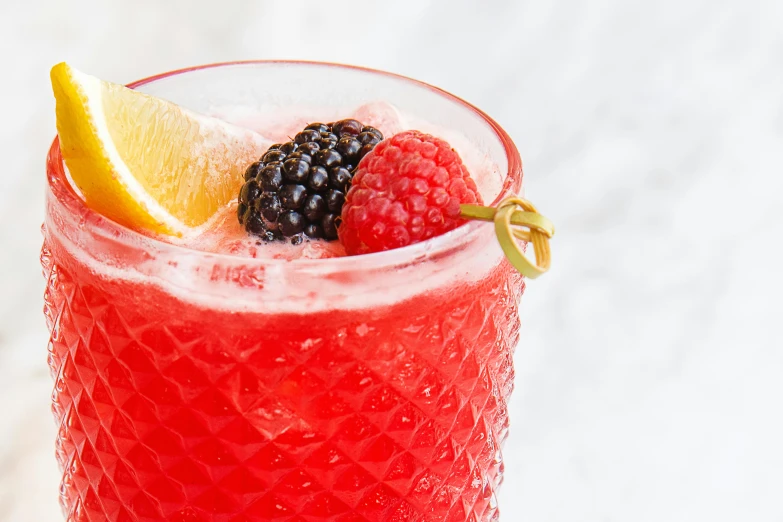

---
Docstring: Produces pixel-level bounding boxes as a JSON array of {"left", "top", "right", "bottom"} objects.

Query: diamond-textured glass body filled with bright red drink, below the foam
[{"left": 41, "top": 238, "right": 523, "bottom": 522}]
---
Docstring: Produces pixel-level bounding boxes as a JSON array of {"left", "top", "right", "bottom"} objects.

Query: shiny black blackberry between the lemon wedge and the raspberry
[{"left": 237, "top": 119, "right": 383, "bottom": 244}]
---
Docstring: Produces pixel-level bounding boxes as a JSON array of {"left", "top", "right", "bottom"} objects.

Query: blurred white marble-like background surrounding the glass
[{"left": 0, "top": 0, "right": 783, "bottom": 522}]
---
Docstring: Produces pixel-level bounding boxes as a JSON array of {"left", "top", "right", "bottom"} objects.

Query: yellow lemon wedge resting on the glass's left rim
[{"left": 51, "top": 63, "right": 269, "bottom": 236}]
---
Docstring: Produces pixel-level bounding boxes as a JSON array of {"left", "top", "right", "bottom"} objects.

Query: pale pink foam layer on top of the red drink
[{"left": 51, "top": 102, "right": 504, "bottom": 313}]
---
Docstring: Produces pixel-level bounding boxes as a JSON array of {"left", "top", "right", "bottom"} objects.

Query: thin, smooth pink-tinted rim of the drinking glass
[{"left": 47, "top": 60, "right": 523, "bottom": 272}]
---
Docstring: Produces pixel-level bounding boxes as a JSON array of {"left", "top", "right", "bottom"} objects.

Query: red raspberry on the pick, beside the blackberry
[{"left": 338, "top": 131, "right": 482, "bottom": 255}]
